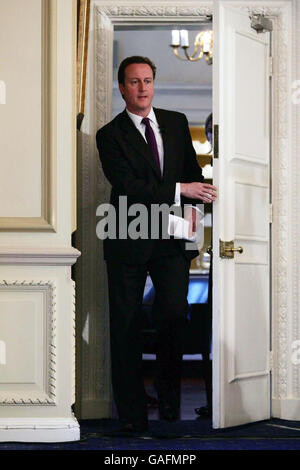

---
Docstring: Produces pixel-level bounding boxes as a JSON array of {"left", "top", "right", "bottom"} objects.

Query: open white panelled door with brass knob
[{"left": 213, "top": 0, "right": 270, "bottom": 428}]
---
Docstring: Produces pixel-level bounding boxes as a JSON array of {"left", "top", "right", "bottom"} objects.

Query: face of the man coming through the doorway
[{"left": 119, "top": 64, "right": 154, "bottom": 117}]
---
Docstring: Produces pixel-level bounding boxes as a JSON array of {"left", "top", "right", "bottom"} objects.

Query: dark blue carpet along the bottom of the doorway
[{"left": 0, "top": 419, "right": 300, "bottom": 451}]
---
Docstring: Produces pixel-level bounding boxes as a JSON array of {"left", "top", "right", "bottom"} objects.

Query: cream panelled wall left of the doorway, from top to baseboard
[{"left": 0, "top": 0, "right": 79, "bottom": 442}]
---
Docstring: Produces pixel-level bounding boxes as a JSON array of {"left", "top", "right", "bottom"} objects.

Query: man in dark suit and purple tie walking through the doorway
[{"left": 96, "top": 56, "right": 216, "bottom": 431}]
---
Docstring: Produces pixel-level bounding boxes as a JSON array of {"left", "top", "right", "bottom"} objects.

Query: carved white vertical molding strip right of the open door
[{"left": 270, "top": 2, "right": 295, "bottom": 399}]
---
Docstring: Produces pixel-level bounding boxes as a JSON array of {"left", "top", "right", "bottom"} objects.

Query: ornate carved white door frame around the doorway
[{"left": 77, "top": 0, "right": 300, "bottom": 419}]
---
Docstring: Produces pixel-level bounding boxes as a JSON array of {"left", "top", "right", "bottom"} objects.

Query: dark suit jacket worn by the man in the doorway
[{"left": 96, "top": 108, "right": 204, "bottom": 264}]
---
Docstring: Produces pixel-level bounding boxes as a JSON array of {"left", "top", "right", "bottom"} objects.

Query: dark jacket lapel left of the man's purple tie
[{"left": 121, "top": 110, "right": 161, "bottom": 179}]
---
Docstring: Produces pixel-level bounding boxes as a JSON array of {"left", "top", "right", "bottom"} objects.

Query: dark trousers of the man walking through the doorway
[{"left": 107, "top": 251, "right": 190, "bottom": 423}]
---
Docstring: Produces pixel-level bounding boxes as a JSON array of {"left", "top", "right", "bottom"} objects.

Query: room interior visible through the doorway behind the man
[{"left": 112, "top": 20, "right": 213, "bottom": 420}]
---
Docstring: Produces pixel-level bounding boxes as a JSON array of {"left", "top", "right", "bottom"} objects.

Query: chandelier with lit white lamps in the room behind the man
[{"left": 171, "top": 29, "right": 213, "bottom": 65}]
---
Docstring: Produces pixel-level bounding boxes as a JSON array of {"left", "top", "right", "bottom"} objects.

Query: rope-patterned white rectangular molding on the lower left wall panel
[{"left": 0, "top": 280, "right": 57, "bottom": 405}]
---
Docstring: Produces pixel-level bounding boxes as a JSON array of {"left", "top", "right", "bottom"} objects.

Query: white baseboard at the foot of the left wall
[{"left": 0, "top": 418, "right": 80, "bottom": 442}]
